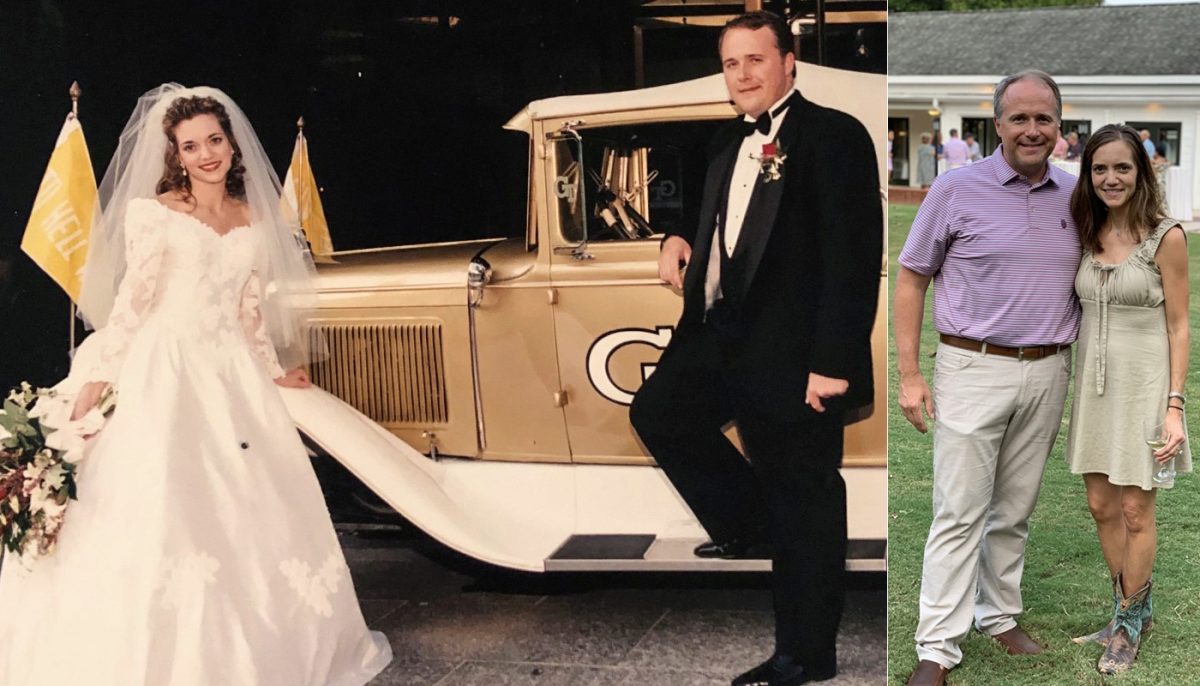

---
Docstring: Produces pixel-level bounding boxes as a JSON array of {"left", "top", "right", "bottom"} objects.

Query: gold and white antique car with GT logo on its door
[{"left": 276, "top": 62, "right": 887, "bottom": 572}]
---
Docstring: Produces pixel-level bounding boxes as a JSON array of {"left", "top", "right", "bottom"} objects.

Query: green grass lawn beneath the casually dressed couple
[{"left": 888, "top": 205, "right": 1200, "bottom": 686}]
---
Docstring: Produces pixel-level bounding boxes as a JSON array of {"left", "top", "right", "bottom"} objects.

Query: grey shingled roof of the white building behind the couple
[{"left": 888, "top": 4, "right": 1200, "bottom": 76}]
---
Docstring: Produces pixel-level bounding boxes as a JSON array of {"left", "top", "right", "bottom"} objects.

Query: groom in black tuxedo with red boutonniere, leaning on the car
[{"left": 630, "top": 12, "right": 883, "bottom": 686}]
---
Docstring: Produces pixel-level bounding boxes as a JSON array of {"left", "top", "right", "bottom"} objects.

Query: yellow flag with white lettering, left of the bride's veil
[{"left": 20, "top": 114, "right": 96, "bottom": 302}]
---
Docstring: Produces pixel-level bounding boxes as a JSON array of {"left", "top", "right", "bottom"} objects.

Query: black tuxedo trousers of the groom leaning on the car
[{"left": 630, "top": 325, "right": 846, "bottom": 670}]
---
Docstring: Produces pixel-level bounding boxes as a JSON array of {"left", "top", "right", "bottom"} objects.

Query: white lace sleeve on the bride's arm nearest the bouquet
[{"left": 84, "top": 206, "right": 166, "bottom": 384}]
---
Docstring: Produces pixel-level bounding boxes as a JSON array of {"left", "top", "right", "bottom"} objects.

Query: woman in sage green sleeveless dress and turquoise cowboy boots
[{"left": 1067, "top": 125, "right": 1192, "bottom": 674}]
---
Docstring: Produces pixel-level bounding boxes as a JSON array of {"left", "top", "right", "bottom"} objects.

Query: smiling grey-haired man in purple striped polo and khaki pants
[{"left": 892, "top": 71, "right": 1080, "bottom": 686}]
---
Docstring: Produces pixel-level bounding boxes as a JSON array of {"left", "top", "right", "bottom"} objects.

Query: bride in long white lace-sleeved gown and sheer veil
[{"left": 0, "top": 84, "right": 391, "bottom": 686}]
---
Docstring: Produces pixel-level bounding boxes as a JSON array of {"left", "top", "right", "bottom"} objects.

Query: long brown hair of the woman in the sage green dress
[{"left": 1070, "top": 124, "right": 1163, "bottom": 254}]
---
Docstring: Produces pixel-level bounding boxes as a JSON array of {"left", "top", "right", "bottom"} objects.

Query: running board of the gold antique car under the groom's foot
[{"left": 546, "top": 534, "right": 888, "bottom": 572}]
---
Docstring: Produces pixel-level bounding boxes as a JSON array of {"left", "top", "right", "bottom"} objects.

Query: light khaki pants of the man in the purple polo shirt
[{"left": 916, "top": 344, "right": 1070, "bottom": 668}]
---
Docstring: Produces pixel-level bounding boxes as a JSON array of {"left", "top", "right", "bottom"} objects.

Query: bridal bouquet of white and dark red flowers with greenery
[{"left": 0, "top": 383, "right": 116, "bottom": 561}]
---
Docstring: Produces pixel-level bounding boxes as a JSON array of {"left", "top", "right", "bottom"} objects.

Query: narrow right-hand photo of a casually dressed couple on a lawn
[{"left": 887, "top": 0, "right": 1200, "bottom": 686}]
